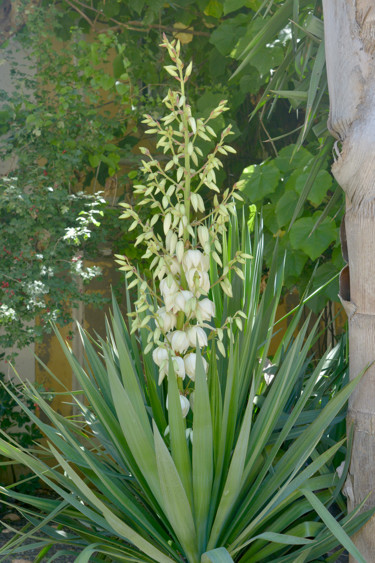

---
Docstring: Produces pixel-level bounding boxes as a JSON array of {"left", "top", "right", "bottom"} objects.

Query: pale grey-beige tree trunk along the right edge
[{"left": 323, "top": 0, "right": 375, "bottom": 563}]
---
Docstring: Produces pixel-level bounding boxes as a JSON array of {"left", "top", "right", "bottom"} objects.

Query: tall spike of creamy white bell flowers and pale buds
[{"left": 117, "top": 37, "right": 249, "bottom": 424}]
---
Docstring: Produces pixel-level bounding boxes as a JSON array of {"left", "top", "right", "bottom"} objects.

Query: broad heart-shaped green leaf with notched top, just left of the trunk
[{"left": 290, "top": 215, "right": 337, "bottom": 260}]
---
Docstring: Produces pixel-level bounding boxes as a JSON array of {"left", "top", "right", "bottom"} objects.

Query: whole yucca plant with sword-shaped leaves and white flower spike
[{"left": 0, "top": 39, "right": 372, "bottom": 563}]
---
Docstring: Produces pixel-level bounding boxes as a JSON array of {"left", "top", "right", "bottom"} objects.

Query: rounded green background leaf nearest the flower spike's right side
[{"left": 240, "top": 161, "right": 280, "bottom": 203}]
